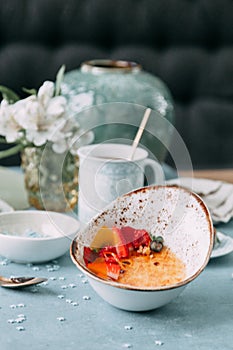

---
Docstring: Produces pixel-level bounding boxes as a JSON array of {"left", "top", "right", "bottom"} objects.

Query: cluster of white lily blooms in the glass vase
[{"left": 0, "top": 65, "right": 90, "bottom": 159}]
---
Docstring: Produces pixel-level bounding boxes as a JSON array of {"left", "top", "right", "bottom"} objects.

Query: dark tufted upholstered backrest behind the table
[{"left": 0, "top": 0, "right": 233, "bottom": 168}]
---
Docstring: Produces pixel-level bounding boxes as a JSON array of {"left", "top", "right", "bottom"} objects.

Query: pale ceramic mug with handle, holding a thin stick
[{"left": 78, "top": 143, "right": 164, "bottom": 223}]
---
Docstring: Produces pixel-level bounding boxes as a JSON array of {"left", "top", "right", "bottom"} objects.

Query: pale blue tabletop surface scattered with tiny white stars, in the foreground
[{"left": 0, "top": 166, "right": 233, "bottom": 350}]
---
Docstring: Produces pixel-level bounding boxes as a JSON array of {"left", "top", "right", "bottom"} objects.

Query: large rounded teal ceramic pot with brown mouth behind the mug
[{"left": 62, "top": 60, "right": 174, "bottom": 160}]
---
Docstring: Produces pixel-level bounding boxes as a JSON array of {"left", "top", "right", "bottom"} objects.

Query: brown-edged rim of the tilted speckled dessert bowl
[{"left": 70, "top": 185, "right": 214, "bottom": 292}]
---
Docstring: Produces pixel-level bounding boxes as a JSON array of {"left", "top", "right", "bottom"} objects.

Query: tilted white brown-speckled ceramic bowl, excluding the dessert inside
[{"left": 70, "top": 186, "right": 214, "bottom": 311}]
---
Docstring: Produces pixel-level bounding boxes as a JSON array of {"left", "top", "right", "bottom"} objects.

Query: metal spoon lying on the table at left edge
[{"left": 0, "top": 276, "right": 48, "bottom": 288}]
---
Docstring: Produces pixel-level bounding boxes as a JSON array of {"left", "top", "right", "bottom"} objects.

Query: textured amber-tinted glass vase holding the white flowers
[{"left": 21, "top": 145, "right": 78, "bottom": 212}]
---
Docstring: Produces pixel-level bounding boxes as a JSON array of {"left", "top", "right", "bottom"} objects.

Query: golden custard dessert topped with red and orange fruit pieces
[{"left": 83, "top": 226, "right": 186, "bottom": 288}]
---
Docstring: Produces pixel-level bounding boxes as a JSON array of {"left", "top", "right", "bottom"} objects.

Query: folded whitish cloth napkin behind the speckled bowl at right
[{"left": 167, "top": 177, "right": 233, "bottom": 223}]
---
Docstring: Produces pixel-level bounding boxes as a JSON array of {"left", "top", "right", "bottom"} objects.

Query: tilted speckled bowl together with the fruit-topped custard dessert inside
[{"left": 70, "top": 186, "right": 214, "bottom": 311}]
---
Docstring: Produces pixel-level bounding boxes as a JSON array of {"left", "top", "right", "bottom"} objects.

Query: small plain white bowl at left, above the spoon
[{"left": 0, "top": 210, "right": 80, "bottom": 263}]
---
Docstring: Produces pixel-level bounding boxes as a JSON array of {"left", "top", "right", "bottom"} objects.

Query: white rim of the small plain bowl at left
[{"left": 0, "top": 210, "right": 81, "bottom": 242}]
